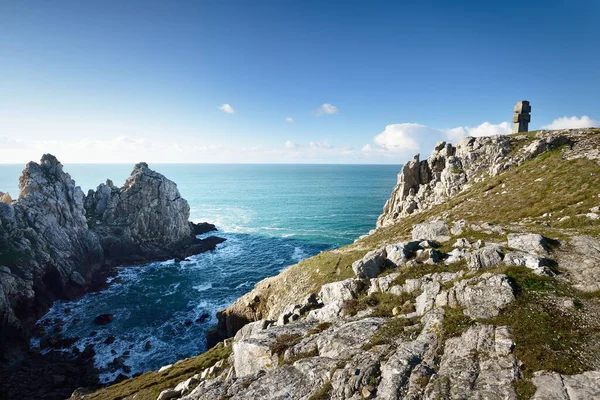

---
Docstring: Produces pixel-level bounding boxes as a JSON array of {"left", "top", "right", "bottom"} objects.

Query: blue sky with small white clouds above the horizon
[{"left": 0, "top": 0, "right": 600, "bottom": 164}]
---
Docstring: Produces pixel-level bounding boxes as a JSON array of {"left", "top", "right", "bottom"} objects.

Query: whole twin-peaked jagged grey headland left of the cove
[{"left": 0, "top": 154, "right": 223, "bottom": 361}]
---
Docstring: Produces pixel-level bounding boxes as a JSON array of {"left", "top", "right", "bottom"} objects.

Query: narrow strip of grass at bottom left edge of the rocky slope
[{"left": 86, "top": 343, "right": 231, "bottom": 400}]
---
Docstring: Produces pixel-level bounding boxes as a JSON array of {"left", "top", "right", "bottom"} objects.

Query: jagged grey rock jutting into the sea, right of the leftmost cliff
[{"left": 85, "top": 163, "right": 223, "bottom": 263}]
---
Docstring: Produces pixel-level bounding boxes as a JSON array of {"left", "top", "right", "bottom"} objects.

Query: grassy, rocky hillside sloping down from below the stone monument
[{"left": 72, "top": 129, "right": 600, "bottom": 400}]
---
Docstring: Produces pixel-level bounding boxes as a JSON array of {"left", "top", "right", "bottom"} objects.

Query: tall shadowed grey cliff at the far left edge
[{"left": 0, "top": 154, "right": 104, "bottom": 359}]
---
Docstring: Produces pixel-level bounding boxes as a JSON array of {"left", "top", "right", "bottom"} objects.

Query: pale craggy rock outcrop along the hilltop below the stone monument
[{"left": 377, "top": 129, "right": 600, "bottom": 227}]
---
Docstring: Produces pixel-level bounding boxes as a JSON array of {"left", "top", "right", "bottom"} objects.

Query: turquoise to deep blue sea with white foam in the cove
[{"left": 0, "top": 164, "right": 400, "bottom": 383}]
